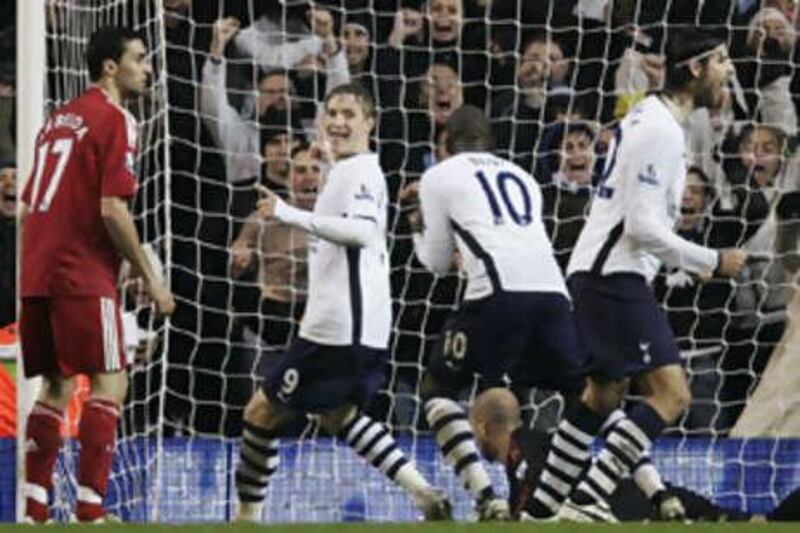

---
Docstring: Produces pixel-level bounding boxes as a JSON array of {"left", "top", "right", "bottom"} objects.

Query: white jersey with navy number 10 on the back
[{"left": 414, "top": 152, "right": 567, "bottom": 300}]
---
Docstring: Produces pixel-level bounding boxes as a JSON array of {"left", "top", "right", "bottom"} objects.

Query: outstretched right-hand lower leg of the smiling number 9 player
[{"left": 320, "top": 405, "right": 452, "bottom": 520}]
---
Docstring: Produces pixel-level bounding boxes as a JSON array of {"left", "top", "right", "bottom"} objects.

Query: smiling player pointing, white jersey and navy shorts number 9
[{"left": 236, "top": 84, "right": 451, "bottom": 521}]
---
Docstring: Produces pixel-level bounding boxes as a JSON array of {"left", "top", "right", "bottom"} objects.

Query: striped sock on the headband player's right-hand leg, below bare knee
[{"left": 573, "top": 403, "right": 665, "bottom": 504}]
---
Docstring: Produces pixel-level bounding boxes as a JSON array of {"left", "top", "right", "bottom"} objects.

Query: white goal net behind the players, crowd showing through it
[{"left": 26, "top": 0, "right": 800, "bottom": 522}]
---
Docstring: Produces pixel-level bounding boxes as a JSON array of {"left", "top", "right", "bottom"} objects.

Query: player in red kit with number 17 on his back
[{"left": 20, "top": 27, "right": 175, "bottom": 522}]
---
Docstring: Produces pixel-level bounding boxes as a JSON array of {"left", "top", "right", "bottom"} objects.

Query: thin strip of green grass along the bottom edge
[{"left": 0, "top": 522, "right": 800, "bottom": 533}]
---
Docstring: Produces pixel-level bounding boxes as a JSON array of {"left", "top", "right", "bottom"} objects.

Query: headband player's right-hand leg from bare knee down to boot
[{"left": 561, "top": 365, "right": 691, "bottom": 521}]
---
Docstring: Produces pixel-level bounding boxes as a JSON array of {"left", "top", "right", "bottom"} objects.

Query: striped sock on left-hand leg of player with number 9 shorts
[{"left": 236, "top": 420, "right": 280, "bottom": 503}]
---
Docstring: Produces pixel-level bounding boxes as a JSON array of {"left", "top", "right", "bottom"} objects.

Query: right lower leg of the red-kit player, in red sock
[{"left": 76, "top": 371, "right": 128, "bottom": 522}]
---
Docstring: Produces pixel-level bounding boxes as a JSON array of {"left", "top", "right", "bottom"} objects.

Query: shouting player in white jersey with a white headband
[{"left": 558, "top": 28, "right": 746, "bottom": 521}]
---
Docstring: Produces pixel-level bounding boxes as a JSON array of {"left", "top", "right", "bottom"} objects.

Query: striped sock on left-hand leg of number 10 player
[{"left": 425, "top": 398, "right": 495, "bottom": 502}]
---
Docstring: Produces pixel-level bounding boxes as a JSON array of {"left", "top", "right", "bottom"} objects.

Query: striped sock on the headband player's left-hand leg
[{"left": 530, "top": 403, "right": 604, "bottom": 518}]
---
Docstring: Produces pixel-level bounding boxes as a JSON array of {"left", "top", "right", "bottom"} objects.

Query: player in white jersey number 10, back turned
[{"left": 405, "top": 106, "right": 603, "bottom": 520}]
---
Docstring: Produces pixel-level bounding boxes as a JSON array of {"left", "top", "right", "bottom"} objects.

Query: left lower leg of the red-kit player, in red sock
[{"left": 23, "top": 375, "right": 75, "bottom": 523}]
